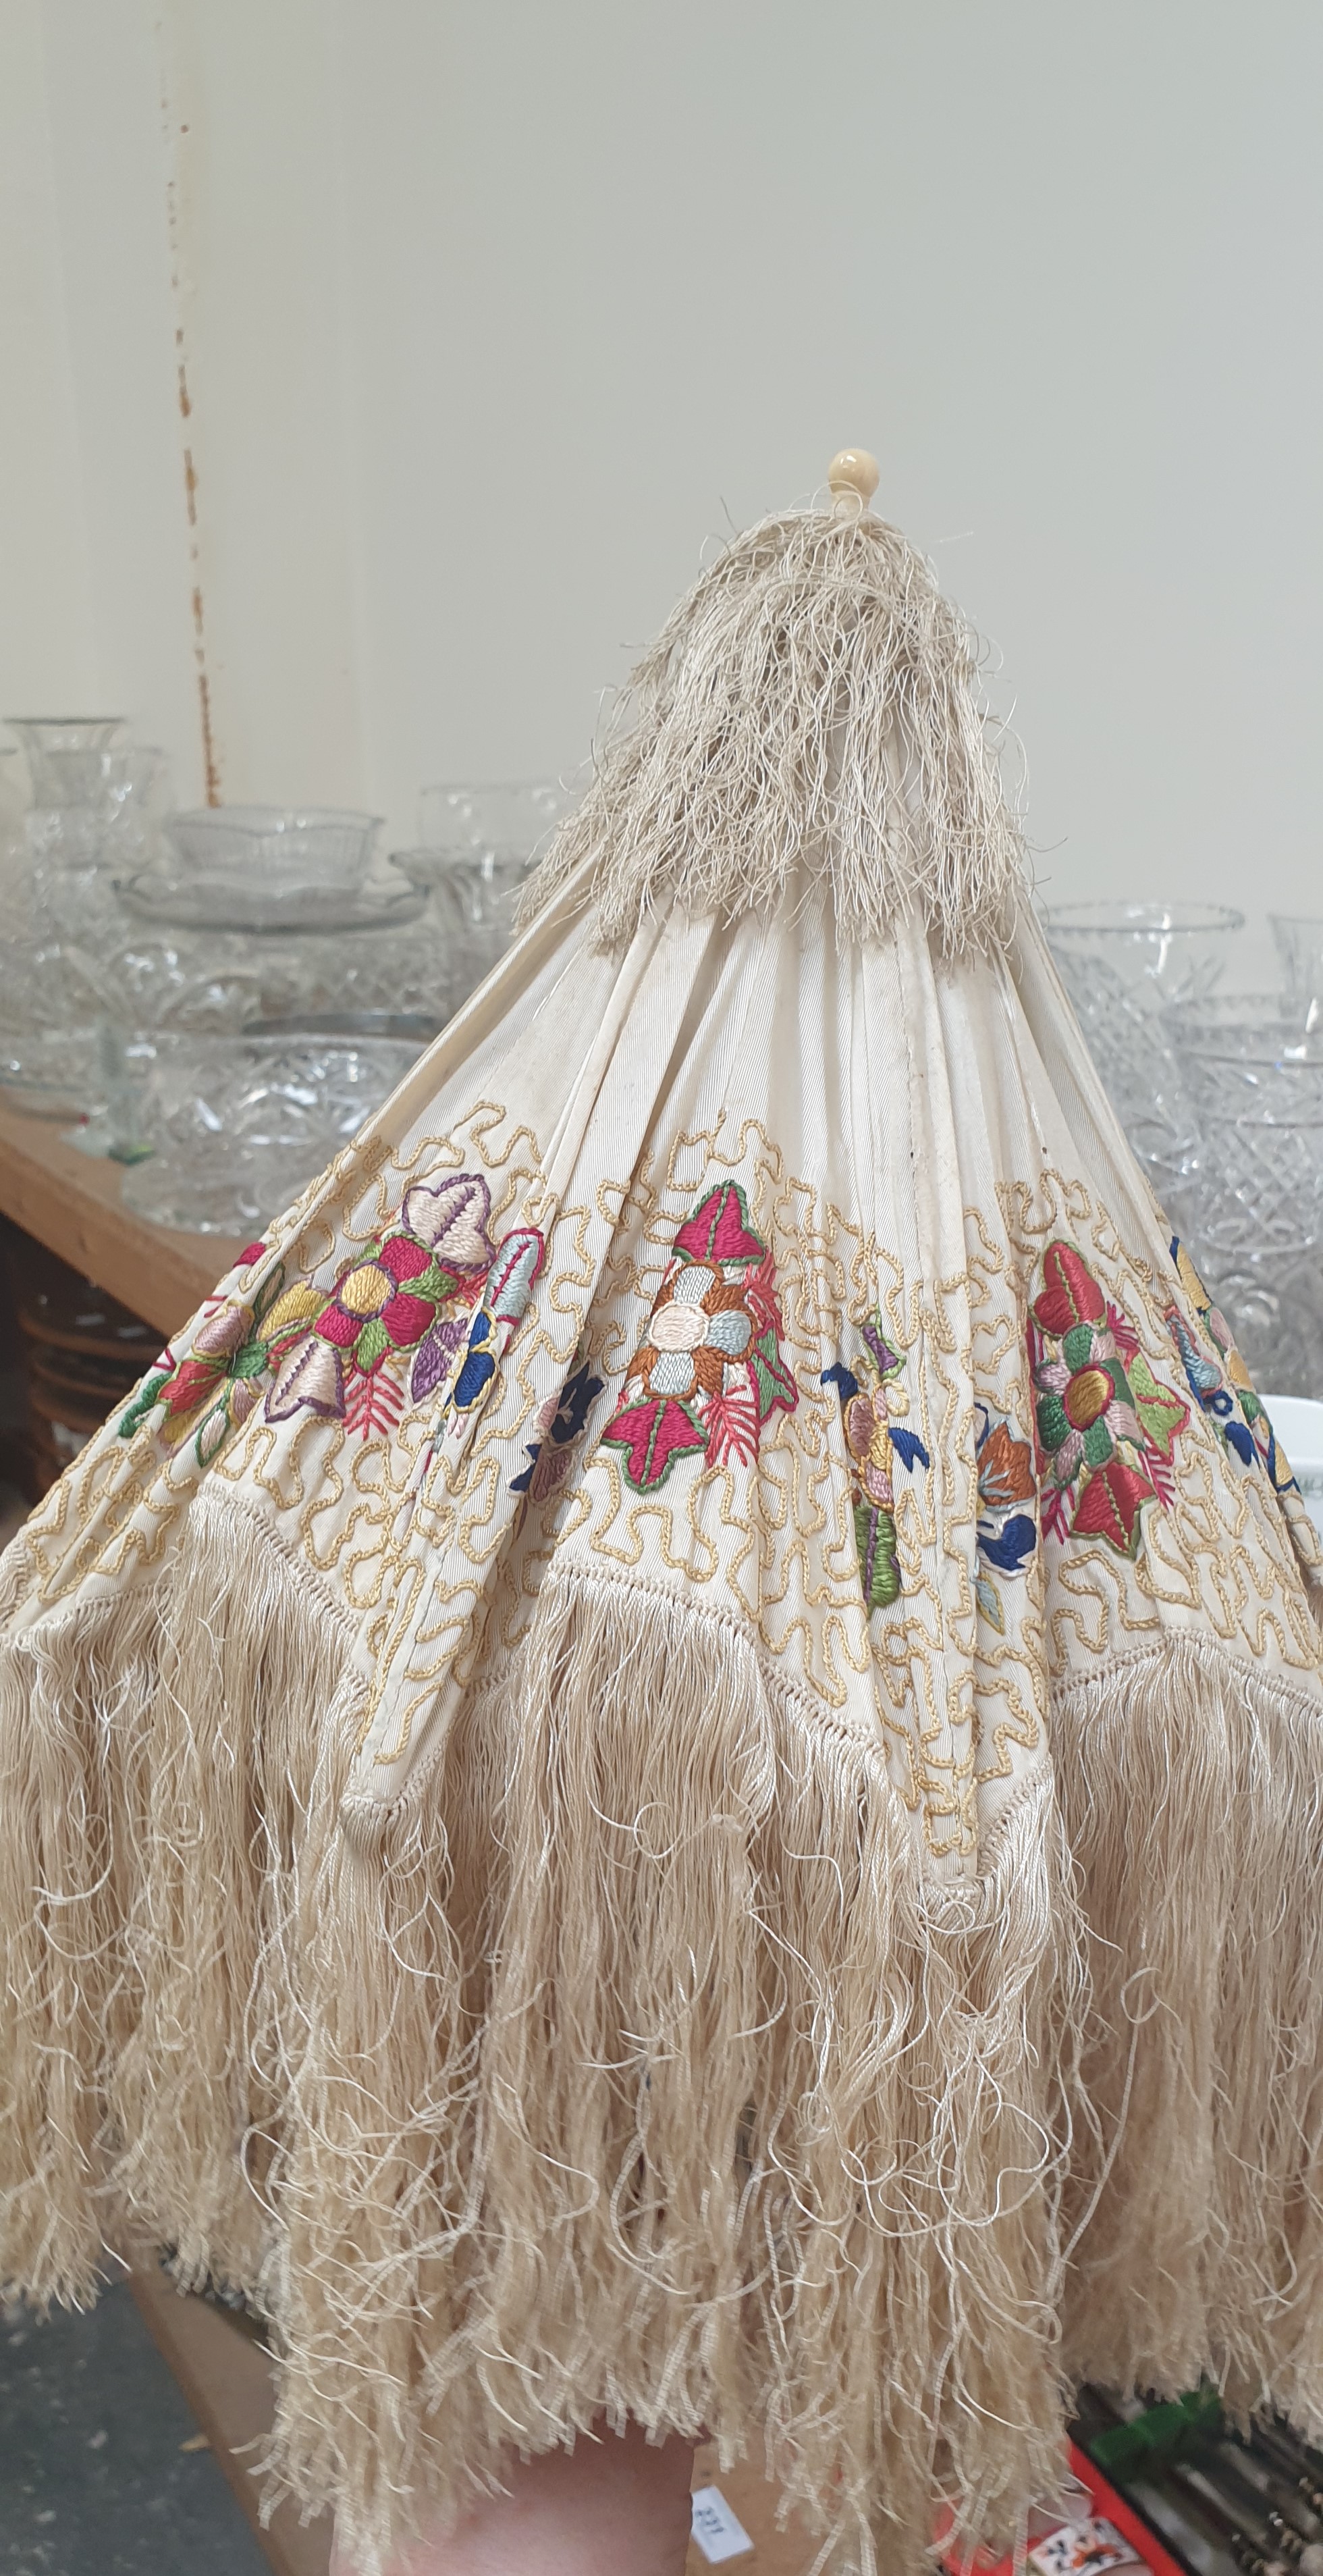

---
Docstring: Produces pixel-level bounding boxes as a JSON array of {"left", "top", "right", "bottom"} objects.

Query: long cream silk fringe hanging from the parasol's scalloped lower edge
[{"left": 0, "top": 1492, "right": 1323, "bottom": 2576}]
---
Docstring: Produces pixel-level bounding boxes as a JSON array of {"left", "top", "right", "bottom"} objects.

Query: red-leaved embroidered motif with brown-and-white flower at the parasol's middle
[{"left": 602, "top": 1180, "right": 798, "bottom": 1494}]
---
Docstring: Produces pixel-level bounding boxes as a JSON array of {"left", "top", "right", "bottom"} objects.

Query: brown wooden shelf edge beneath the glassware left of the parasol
[{"left": 0, "top": 1097, "right": 242, "bottom": 1337}]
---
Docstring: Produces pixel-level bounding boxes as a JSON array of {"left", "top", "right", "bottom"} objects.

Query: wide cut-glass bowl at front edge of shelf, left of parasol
[{"left": 124, "top": 1030, "right": 420, "bottom": 1234}]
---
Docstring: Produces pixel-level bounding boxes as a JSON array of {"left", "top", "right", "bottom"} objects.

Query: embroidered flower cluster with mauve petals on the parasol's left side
[{"left": 265, "top": 1172, "right": 543, "bottom": 1432}]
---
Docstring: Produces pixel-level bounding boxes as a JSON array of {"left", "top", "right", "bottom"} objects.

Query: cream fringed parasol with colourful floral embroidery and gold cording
[{"left": 0, "top": 487, "right": 1323, "bottom": 2571}]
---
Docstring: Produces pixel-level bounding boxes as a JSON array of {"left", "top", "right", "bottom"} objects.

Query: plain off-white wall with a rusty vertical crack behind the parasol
[{"left": 0, "top": 0, "right": 1323, "bottom": 947}]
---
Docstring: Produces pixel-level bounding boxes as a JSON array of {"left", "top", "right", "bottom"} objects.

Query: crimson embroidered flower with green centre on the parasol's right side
[{"left": 1029, "top": 1242, "right": 1189, "bottom": 1556}]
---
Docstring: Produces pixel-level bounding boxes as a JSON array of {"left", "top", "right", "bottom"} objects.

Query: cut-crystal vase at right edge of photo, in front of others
[{"left": 1168, "top": 995, "right": 1323, "bottom": 1396}]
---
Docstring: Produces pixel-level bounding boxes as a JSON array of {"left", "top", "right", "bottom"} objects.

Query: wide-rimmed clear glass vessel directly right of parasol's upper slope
[{"left": 1042, "top": 904, "right": 1246, "bottom": 1205}]
